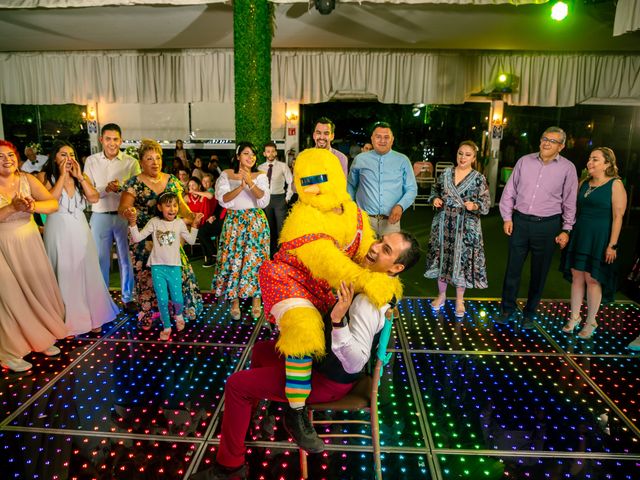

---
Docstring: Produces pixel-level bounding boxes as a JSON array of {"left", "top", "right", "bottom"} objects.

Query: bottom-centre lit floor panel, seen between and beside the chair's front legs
[{"left": 197, "top": 444, "right": 433, "bottom": 480}]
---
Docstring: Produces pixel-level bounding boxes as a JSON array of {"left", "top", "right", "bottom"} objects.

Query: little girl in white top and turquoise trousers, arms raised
[{"left": 125, "top": 192, "right": 203, "bottom": 341}]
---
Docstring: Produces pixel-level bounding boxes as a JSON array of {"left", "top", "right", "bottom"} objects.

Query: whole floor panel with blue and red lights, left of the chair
[{"left": 12, "top": 342, "right": 243, "bottom": 437}]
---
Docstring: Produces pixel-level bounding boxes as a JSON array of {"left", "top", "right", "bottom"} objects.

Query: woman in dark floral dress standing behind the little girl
[{"left": 118, "top": 140, "right": 202, "bottom": 330}]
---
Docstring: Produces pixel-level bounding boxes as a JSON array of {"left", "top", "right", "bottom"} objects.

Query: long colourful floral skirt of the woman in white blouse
[{"left": 211, "top": 208, "right": 270, "bottom": 300}]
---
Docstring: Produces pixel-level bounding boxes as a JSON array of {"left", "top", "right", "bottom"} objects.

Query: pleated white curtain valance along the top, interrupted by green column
[{"left": 0, "top": 49, "right": 640, "bottom": 106}]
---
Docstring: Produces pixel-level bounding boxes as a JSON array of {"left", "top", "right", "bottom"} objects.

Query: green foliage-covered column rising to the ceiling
[{"left": 233, "top": 0, "right": 274, "bottom": 152}]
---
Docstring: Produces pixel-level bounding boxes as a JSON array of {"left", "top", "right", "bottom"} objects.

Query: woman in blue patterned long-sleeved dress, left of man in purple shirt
[{"left": 424, "top": 140, "right": 491, "bottom": 317}]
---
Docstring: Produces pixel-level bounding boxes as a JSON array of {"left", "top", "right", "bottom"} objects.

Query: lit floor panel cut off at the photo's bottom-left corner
[{"left": 0, "top": 431, "right": 198, "bottom": 480}]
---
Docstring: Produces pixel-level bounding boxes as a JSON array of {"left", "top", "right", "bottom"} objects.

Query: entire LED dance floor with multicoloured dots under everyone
[{"left": 0, "top": 295, "right": 640, "bottom": 480}]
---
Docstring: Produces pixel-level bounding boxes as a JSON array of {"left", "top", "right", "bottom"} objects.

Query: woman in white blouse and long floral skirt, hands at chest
[{"left": 212, "top": 142, "right": 270, "bottom": 320}]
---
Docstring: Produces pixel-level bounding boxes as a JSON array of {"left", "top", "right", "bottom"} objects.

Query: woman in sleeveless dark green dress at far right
[{"left": 561, "top": 147, "right": 627, "bottom": 339}]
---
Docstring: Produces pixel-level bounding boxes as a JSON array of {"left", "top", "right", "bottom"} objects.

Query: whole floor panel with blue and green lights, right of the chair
[{"left": 412, "top": 354, "right": 640, "bottom": 454}]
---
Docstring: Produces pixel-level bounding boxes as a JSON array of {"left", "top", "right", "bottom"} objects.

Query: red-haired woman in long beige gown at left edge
[{"left": 0, "top": 140, "right": 67, "bottom": 372}]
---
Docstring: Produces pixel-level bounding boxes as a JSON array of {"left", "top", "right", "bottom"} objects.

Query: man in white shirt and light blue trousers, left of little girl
[{"left": 84, "top": 123, "right": 140, "bottom": 313}]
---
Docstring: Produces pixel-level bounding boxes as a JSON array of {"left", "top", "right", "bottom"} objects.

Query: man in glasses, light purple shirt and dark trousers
[{"left": 497, "top": 127, "right": 578, "bottom": 328}]
